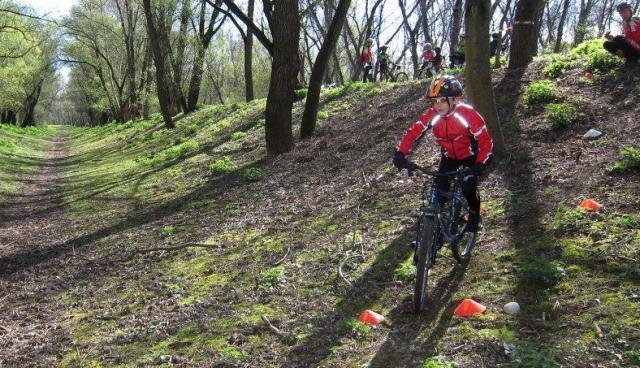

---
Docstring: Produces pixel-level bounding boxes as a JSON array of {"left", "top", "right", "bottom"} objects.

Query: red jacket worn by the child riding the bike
[{"left": 397, "top": 104, "right": 493, "bottom": 164}]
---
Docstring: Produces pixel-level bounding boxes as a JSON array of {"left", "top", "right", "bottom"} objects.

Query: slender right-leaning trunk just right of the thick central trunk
[{"left": 300, "top": 0, "right": 351, "bottom": 138}]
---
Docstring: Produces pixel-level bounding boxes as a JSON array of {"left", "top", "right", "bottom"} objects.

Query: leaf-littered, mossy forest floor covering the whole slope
[{"left": 0, "top": 56, "right": 640, "bottom": 368}]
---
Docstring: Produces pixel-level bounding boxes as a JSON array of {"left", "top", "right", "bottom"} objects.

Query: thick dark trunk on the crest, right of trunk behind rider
[{"left": 509, "top": 0, "right": 545, "bottom": 69}]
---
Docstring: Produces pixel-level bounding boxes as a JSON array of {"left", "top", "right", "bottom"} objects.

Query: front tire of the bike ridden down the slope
[{"left": 413, "top": 214, "right": 435, "bottom": 313}]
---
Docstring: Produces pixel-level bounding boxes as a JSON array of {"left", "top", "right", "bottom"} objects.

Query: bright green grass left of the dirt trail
[{"left": 0, "top": 125, "right": 56, "bottom": 200}]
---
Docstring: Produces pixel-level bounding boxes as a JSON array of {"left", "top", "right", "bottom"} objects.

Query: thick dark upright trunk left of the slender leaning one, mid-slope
[{"left": 262, "top": 0, "right": 300, "bottom": 156}]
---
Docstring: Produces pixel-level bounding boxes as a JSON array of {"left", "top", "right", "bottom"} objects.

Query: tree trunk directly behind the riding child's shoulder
[{"left": 465, "top": 0, "right": 505, "bottom": 159}]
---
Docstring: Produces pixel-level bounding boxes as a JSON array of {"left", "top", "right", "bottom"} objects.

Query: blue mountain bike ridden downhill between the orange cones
[{"left": 411, "top": 163, "right": 476, "bottom": 313}]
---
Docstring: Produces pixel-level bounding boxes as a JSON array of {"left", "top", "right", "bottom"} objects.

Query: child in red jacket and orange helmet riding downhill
[{"left": 393, "top": 75, "right": 493, "bottom": 241}]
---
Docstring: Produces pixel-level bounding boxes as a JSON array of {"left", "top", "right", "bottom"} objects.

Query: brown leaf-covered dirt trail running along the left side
[{"left": 0, "top": 132, "right": 74, "bottom": 367}]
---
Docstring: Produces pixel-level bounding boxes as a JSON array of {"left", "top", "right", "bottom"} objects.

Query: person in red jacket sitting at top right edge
[{"left": 604, "top": 3, "right": 640, "bottom": 65}]
